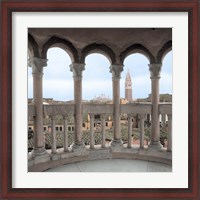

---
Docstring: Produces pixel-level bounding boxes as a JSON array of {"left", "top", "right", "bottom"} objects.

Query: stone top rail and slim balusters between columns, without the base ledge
[{"left": 28, "top": 103, "right": 172, "bottom": 159}]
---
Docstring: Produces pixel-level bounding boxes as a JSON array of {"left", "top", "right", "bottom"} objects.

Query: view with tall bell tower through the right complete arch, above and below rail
[{"left": 121, "top": 53, "right": 151, "bottom": 147}]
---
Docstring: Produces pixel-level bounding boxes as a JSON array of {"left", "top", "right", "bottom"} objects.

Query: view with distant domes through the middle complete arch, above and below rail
[{"left": 83, "top": 53, "right": 113, "bottom": 148}]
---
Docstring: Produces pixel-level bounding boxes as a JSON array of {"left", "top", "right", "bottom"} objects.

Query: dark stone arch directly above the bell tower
[{"left": 120, "top": 44, "right": 155, "bottom": 63}]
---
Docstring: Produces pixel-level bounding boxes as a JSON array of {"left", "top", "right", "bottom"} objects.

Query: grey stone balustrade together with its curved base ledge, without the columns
[{"left": 28, "top": 103, "right": 172, "bottom": 171}]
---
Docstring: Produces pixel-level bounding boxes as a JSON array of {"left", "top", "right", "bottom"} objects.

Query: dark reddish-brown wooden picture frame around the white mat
[{"left": 0, "top": 0, "right": 200, "bottom": 200}]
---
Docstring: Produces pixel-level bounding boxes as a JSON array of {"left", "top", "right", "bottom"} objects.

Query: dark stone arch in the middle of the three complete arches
[{"left": 81, "top": 43, "right": 116, "bottom": 65}]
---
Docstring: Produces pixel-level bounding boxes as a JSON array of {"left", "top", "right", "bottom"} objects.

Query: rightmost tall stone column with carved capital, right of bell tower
[{"left": 149, "top": 64, "right": 162, "bottom": 149}]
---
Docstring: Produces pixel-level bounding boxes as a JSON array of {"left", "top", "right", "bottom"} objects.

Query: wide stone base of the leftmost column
[{"left": 29, "top": 147, "right": 51, "bottom": 165}]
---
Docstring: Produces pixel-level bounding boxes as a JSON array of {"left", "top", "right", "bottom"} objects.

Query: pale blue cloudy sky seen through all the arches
[{"left": 28, "top": 48, "right": 172, "bottom": 101}]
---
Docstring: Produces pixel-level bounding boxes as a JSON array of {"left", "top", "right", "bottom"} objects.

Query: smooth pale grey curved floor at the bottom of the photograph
[{"left": 46, "top": 159, "right": 172, "bottom": 172}]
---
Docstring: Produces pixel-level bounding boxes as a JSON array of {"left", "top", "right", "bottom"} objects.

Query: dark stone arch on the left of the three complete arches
[{"left": 42, "top": 36, "right": 79, "bottom": 62}]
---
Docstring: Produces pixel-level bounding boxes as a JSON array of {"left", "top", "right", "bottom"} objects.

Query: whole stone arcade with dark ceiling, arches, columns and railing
[{"left": 28, "top": 28, "right": 172, "bottom": 170}]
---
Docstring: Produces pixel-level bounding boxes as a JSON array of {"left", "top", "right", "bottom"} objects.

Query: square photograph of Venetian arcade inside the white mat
[{"left": 27, "top": 28, "right": 173, "bottom": 172}]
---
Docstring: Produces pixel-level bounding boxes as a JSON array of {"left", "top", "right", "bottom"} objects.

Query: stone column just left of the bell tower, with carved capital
[{"left": 110, "top": 65, "right": 123, "bottom": 148}]
